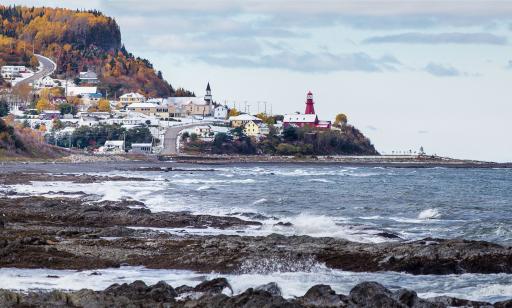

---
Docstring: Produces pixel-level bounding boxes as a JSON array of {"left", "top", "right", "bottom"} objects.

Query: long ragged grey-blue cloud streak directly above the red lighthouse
[{"left": 198, "top": 51, "right": 400, "bottom": 73}]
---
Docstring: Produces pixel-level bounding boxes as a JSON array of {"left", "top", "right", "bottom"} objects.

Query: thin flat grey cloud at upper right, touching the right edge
[{"left": 363, "top": 32, "right": 507, "bottom": 45}]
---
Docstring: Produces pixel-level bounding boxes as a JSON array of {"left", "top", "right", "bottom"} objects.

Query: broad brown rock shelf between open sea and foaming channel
[{"left": 0, "top": 196, "right": 512, "bottom": 274}]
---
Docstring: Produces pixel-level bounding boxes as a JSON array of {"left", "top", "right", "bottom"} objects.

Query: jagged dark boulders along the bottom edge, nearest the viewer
[{"left": 0, "top": 278, "right": 512, "bottom": 308}]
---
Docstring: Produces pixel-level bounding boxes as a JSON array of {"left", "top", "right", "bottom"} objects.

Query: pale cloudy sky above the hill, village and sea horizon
[{"left": 7, "top": 0, "right": 512, "bottom": 162}]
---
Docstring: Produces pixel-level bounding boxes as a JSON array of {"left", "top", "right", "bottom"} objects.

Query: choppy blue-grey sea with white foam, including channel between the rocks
[{"left": 0, "top": 164, "right": 512, "bottom": 301}]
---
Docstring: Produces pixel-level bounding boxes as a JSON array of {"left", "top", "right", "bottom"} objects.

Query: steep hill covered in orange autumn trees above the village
[{"left": 0, "top": 5, "right": 180, "bottom": 96}]
